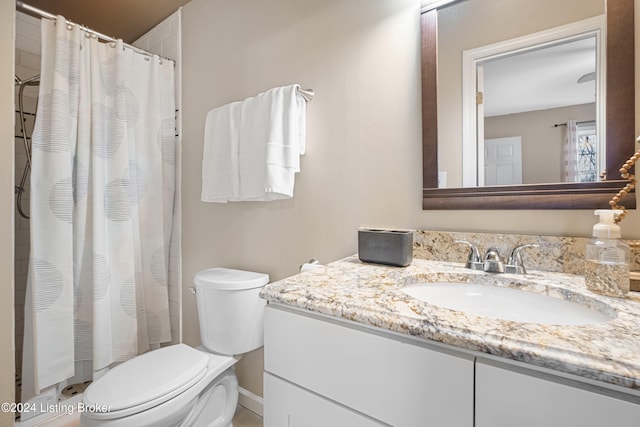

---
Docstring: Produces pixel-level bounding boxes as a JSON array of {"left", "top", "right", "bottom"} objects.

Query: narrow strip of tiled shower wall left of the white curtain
[{"left": 14, "top": 12, "right": 40, "bottom": 384}]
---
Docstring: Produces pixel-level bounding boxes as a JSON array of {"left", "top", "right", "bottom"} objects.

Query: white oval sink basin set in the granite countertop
[{"left": 401, "top": 282, "right": 612, "bottom": 325}]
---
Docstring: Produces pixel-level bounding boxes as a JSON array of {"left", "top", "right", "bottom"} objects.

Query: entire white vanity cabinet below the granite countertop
[{"left": 264, "top": 304, "right": 640, "bottom": 427}]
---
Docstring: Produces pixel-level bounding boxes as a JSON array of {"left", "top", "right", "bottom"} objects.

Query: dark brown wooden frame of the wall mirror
[{"left": 421, "top": 0, "right": 636, "bottom": 210}]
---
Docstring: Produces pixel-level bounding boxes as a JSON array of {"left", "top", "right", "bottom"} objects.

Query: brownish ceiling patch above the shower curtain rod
[{"left": 19, "top": 0, "right": 190, "bottom": 43}]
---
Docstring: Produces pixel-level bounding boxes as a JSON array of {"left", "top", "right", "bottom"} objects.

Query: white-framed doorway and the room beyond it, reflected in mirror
[{"left": 462, "top": 16, "right": 605, "bottom": 186}]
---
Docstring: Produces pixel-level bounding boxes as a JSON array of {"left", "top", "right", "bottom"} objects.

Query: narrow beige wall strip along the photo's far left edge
[{"left": 0, "top": 0, "right": 15, "bottom": 426}]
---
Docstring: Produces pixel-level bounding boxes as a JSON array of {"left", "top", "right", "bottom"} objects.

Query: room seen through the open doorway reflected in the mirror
[{"left": 484, "top": 36, "right": 604, "bottom": 185}]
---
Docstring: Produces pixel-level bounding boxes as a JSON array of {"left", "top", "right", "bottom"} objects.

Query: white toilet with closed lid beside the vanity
[{"left": 79, "top": 268, "right": 269, "bottom": 427}]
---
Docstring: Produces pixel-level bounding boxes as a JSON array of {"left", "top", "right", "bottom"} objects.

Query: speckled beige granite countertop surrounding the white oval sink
[{"left": 261, "top": 256, "right": 640, "bottom": 390}]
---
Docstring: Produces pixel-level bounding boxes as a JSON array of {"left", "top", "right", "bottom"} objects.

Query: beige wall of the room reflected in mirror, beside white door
[{"left": 484, "top": 103, "right": 596, "bottom": 184}]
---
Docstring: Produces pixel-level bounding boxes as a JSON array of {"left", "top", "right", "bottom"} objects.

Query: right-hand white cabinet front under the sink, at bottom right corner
[{"left": 475, "top": 360, "right": 640, "bottom": 427}]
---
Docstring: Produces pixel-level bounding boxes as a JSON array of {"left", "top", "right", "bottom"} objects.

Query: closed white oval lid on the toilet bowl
[{"left": 83, "top": 344, "right": 209, "bottom": 412}]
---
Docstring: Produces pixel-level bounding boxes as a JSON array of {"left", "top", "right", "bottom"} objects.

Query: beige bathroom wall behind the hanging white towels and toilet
[{"left": 183, "top": 0, "right": 640, "bottom": 400}]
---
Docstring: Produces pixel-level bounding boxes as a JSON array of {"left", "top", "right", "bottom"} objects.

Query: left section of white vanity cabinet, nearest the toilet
[{"left": 264, "top": 304, "right": 474, "bottom": 427}]
